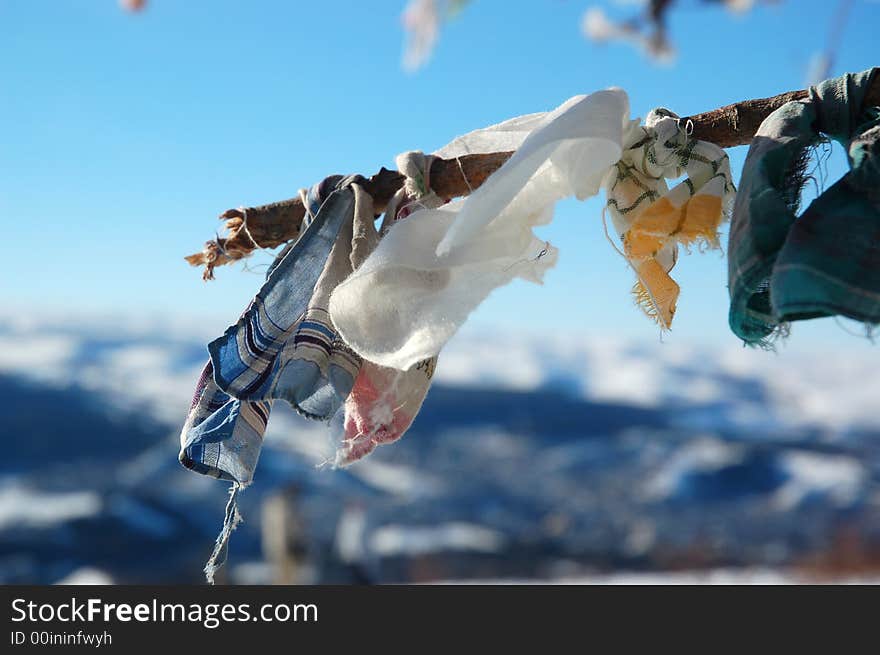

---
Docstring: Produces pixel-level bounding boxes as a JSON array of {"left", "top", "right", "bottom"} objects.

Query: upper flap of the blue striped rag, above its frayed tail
[{"left": 208, "top": 177, "right": 373, "bottom": 420}]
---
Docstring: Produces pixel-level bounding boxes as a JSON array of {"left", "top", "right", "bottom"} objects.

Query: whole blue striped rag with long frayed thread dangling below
[{"left": 179, "top": 176, "right": 377, "bottom": 583}]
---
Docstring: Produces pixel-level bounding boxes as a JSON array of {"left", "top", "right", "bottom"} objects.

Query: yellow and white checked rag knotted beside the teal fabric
[{"left": 603, "top": 109, "right": 736, "bottom": 330}]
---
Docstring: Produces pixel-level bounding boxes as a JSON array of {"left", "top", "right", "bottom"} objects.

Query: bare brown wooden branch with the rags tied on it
[{"left": 186, "top": 75, "right": 880, "bottom": 280}]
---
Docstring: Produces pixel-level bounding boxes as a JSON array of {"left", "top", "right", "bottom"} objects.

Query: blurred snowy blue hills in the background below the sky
[{"left": 0, "top": 316, "right": 880, "bottom": 583}]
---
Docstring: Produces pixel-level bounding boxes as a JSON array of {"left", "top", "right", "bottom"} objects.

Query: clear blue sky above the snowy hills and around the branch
[{"left": 0, "top": 0, "right": 880, "bottom": 352}]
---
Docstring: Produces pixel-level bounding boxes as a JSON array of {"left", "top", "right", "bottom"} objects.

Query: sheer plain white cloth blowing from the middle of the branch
[{"left": 330, "top": 89, "right": 629, "bottom": 370}]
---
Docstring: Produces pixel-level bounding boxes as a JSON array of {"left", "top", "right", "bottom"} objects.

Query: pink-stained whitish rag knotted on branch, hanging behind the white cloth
[{"left": 335, "top": 152, "right": 444, "bottom": 466}]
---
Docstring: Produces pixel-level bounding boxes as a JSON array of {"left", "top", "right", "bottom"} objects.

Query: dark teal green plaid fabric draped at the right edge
[{"left": 728, "top": 68, "right": 880, "bottom": 345}]
